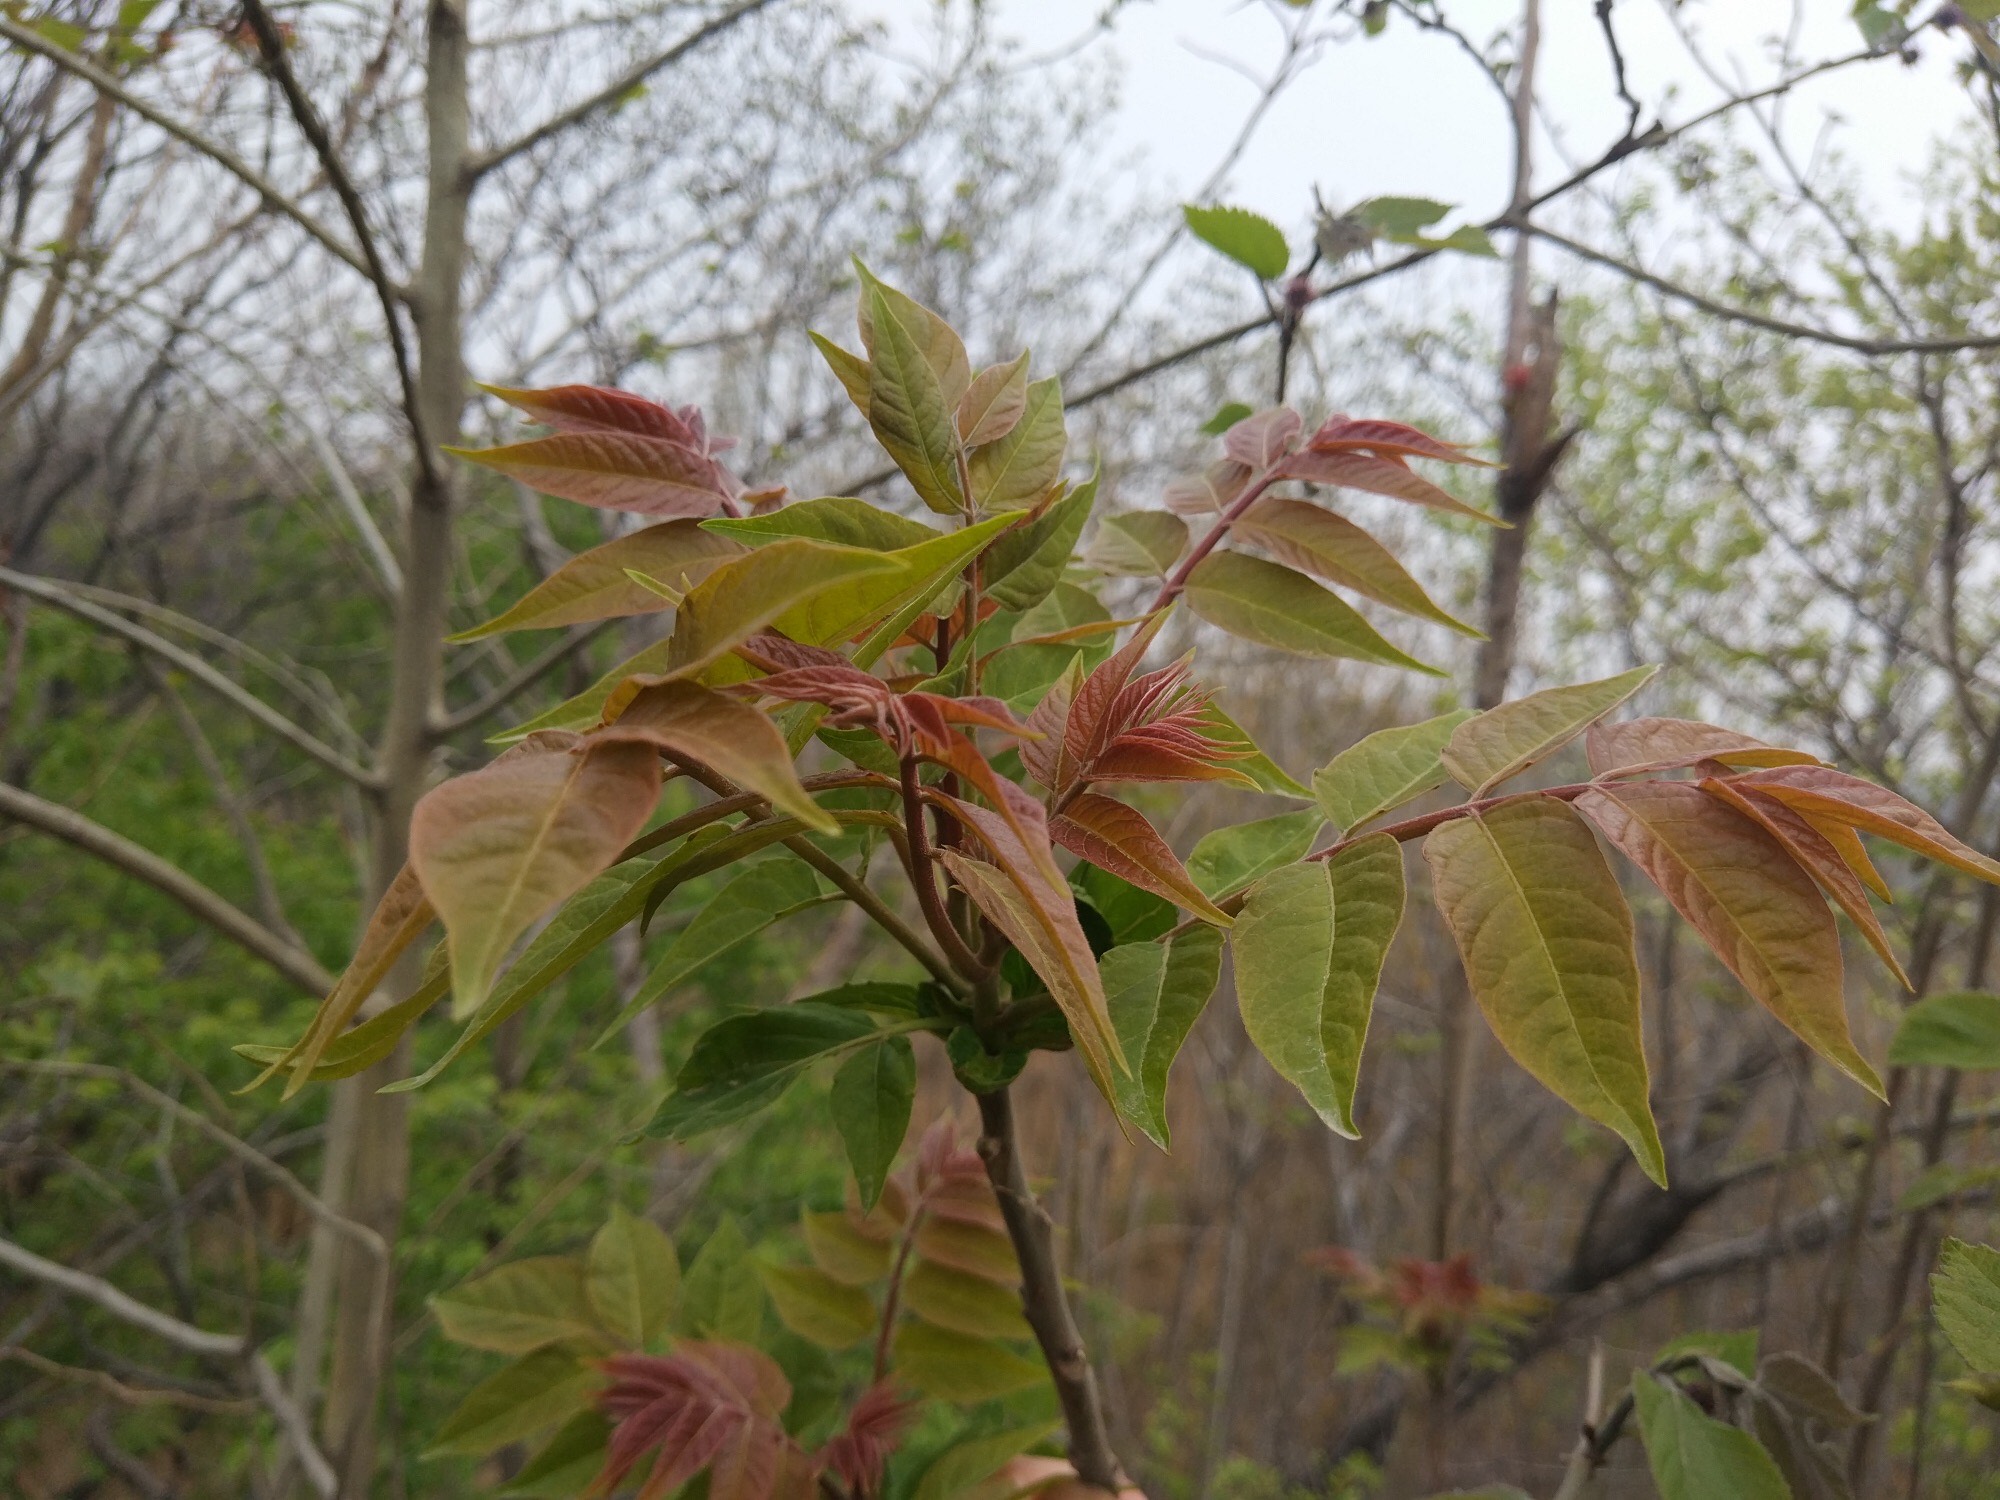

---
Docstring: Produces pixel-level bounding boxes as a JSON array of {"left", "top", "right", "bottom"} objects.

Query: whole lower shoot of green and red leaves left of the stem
[{"left": 432, "top": 1120, "right": 1050, "bottom": 1500}]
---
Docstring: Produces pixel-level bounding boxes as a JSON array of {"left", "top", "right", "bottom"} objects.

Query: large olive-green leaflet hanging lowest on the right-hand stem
[{"left": 1424, "top": 804, "right": 1666, "bottom": 1186}]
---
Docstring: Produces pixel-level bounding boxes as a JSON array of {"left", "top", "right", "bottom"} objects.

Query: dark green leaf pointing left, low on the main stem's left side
[{"left": 646, "top": 1002, "right": 876, "bottom": 1140}]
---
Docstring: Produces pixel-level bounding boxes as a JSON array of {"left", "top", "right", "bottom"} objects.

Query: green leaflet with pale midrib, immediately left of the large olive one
[{"left": 1230, "top": 836, "right": 1404, "bottom": 1138}]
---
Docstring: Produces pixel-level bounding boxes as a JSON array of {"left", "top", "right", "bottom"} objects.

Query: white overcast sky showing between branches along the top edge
[{"left": 862, "top": 0, "right": 1966, "bottom": 230}]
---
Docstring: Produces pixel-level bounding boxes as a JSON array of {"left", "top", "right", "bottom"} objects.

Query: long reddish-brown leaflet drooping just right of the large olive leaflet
[{"left": 1576, "top": 782, "right": 1882, "bottom": 1098}]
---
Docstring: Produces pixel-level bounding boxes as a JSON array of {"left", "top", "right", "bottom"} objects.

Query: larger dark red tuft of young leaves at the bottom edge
[{"left": 590, "top": 1340, "right": 812, "bottom": 1500}]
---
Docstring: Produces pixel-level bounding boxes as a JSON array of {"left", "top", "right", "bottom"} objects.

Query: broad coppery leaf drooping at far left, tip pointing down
[{"left": 410, "top": 736, "right": 660, "bottom": 1020}]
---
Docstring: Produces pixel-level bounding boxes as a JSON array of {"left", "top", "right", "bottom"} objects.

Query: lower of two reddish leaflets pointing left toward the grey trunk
[{"left": 446, "top": 432, "right": 730, "bottom": 516}]
